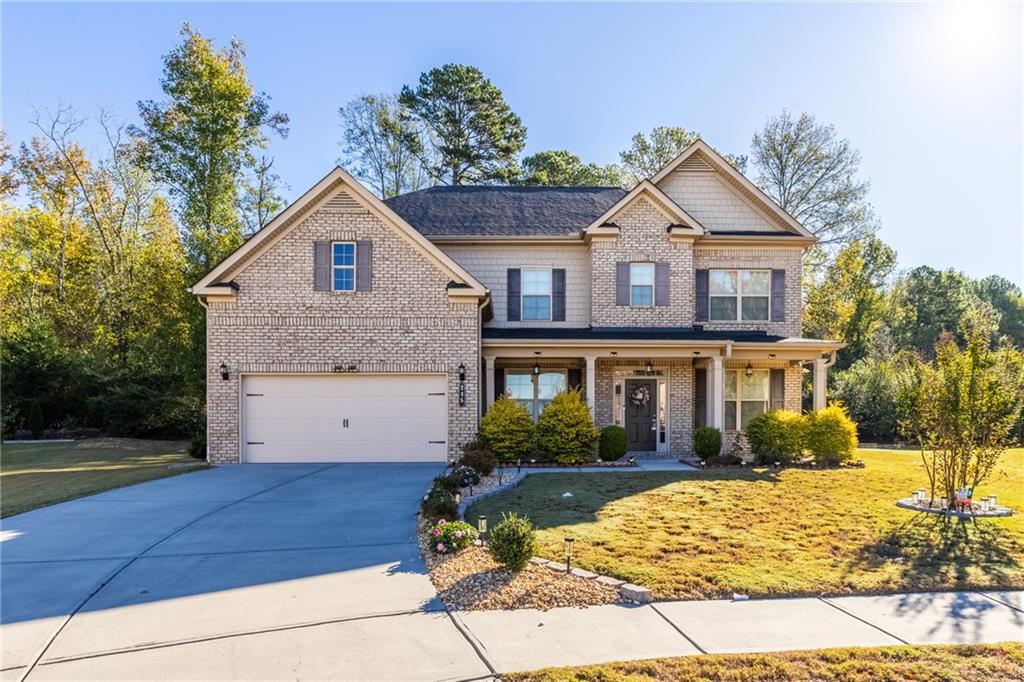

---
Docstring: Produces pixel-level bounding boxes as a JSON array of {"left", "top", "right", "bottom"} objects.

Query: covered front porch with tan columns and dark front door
[{"left": 481, "top": 329, "right": 840, "bottom": 457}]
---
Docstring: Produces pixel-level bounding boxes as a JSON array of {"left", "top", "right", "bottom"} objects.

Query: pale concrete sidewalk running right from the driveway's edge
[{"left": 453, "top": 592, "right": 1024, "bottom": 673}]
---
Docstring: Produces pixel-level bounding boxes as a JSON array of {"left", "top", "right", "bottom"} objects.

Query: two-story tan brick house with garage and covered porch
[{"left": 193, "top": 142, "right": 841, "bottom": 463}]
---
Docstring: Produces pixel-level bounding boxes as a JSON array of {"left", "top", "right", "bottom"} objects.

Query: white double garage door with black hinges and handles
[{"left": 242, "top": 375, "right": 447, "bottom": 463}]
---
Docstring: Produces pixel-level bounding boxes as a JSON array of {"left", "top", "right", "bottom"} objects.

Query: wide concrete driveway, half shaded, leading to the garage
[{"left": 0, "top": 464, "right": 489, "bottom": 680}]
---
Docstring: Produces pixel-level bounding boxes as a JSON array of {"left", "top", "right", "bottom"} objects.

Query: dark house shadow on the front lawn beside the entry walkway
[{"left": 465, "top": 468, "right": 778, "bottom": 529}]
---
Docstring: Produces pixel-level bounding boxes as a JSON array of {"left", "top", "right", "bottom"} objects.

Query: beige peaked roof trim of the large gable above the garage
[{"left": 189, "top": 167, "right": 486, "bottom": 296}]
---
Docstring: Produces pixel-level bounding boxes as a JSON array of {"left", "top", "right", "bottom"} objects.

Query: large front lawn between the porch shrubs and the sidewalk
[{"left": 466, "top": 449, "right": 1024, "bottom": 599}]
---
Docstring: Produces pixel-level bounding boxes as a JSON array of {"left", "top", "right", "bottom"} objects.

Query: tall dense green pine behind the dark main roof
[{"left": 398, "top": 63, "right": 526, "bottom": 185}]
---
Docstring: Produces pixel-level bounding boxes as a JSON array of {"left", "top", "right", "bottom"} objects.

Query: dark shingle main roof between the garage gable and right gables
[{"left": 387, "top": 186, "right": 626, "bottom": 237}]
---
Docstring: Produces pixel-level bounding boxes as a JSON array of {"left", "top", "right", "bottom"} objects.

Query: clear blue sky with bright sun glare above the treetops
[{"left": 6, "top": 2, "right": 1024, "bottom": 284}]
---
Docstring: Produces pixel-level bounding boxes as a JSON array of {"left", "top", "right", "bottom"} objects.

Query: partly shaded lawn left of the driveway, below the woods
[{"left": 0, "top": 438, "right": 203, "bottom": 517}]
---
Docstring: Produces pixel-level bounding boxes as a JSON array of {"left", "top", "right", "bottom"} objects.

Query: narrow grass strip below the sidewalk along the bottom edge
[{"left": 502, "top": 642, "right": 1024, "bottom": 682}]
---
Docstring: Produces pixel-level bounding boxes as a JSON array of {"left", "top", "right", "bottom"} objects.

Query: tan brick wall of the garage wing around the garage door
[{"left": 207, "top": 188, "right": 480, "bottom": 464}]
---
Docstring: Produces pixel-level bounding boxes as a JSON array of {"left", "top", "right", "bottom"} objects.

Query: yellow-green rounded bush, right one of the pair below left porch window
[{"left": 537, "top": 390, "right": 600, "bottom": 465}]
